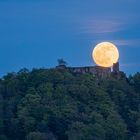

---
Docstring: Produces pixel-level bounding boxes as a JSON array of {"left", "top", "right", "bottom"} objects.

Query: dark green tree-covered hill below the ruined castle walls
[{"left": 0, "top": 69, "right": 140, "bottom": 140}]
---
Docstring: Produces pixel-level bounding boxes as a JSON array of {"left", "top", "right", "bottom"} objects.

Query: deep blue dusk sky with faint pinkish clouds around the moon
[{"left": 0, "top": 0, "right": 140, "bottom": 75}]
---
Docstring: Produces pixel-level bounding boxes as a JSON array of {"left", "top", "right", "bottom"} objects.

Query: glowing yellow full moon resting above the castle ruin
[{"left": 92, "top": 42, "right": 119, "bottom": 67}]
